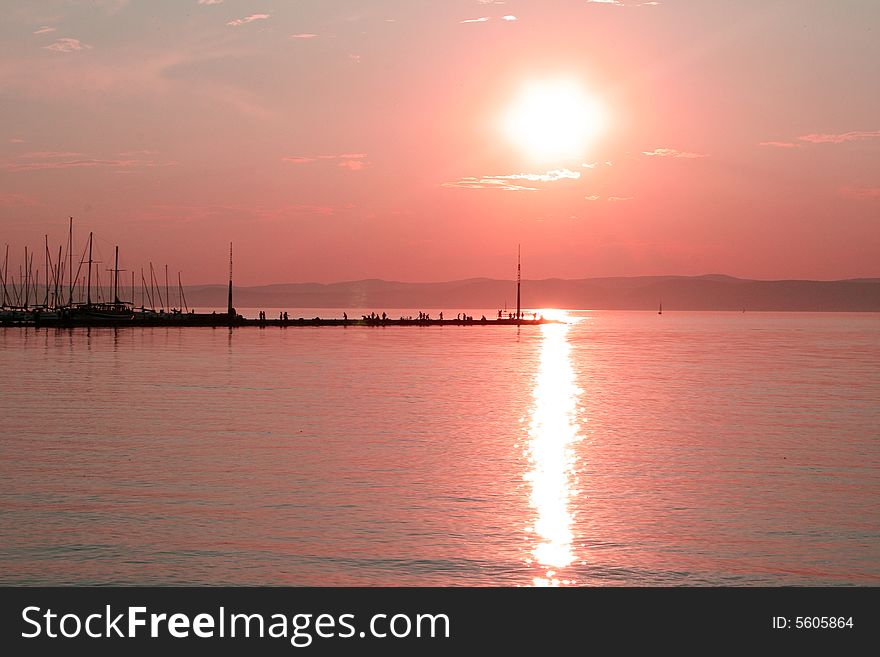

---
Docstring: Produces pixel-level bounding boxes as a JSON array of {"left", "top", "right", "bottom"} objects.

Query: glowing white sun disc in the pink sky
[{"left": 501, "top": 80, "right": 605, "bottom": 161}]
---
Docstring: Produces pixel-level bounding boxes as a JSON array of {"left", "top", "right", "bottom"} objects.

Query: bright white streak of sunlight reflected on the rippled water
[{"left": 525, "top": 311, "right": 581, "bottom": 586}]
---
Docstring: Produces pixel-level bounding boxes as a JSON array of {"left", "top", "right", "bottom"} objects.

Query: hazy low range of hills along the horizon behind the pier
[{"left": 180, "top": 274, "right": 880, "bottom": 312}]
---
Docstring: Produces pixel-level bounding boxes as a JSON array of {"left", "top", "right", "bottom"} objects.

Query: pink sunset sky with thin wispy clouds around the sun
[{"left": 0, "top": 0, "right": 880, "bottom": 285}]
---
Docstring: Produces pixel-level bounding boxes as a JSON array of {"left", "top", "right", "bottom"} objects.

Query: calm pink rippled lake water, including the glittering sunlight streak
[{"left": 0, "top": 309, "right": 880, "bottom": 586}]
